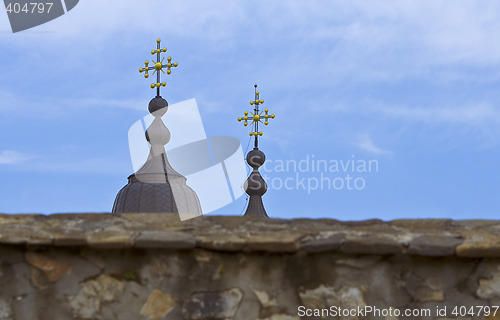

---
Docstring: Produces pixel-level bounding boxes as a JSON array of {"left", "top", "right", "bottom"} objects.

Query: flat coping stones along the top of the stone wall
[{"left": 0, "top": 213, "right": 500, "bottom": 258}]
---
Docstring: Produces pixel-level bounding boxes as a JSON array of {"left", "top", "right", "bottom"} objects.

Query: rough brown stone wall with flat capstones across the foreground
[{"left": 0, "top": 214, "right": 500, "bottom": 320}]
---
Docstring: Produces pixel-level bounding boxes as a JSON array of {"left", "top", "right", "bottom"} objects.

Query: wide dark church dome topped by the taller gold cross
[{"left": 112, "top": 39, "right": 202, "bottom": 220}]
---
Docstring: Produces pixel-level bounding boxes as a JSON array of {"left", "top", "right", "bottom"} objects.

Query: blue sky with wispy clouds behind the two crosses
[{"left": 0, "top": 0, "right": 500, "bottom": 220}]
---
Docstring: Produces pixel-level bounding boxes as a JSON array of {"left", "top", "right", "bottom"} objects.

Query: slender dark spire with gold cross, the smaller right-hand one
[{"left": 238, "top": 84, "right": 274, "bottom": 217}]
